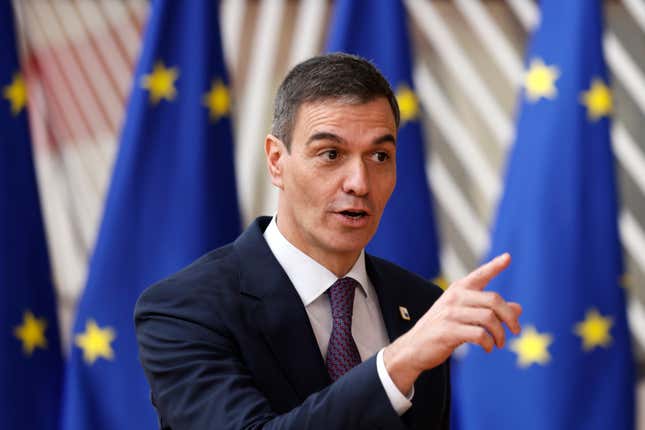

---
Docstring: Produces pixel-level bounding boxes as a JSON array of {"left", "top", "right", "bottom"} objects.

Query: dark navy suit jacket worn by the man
[{"left": 135, "top": 217, "right": 450, "bottom": 430}]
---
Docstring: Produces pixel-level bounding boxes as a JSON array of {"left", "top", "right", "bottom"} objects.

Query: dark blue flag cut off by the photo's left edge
[{"left": 0, "top": 2, "right": 63, "bottom": 430}]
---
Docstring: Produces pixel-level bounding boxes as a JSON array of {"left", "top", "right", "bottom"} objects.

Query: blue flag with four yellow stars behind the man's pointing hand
[{"left": 453, "top": 0, "right": 634, "bottom": 430}]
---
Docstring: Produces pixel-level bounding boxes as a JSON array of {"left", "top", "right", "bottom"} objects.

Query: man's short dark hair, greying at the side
[{"left": 271, "top": 53, "right": 401, "bottom": 149}]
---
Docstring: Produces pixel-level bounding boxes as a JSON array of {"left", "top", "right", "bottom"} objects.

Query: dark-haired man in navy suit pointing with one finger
[{"left": 135, "top": 54, "right": 521, "bottom": 429}]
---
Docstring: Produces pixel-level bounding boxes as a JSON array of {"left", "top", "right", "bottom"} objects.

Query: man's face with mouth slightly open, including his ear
[{"left": 268, "top": 98, "right": 396, "bottom": 261}]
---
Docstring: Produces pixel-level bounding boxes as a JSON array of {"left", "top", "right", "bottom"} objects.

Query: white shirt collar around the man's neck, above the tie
[{"left": 264, "top": 216, "right": 369, "bottom": 306}]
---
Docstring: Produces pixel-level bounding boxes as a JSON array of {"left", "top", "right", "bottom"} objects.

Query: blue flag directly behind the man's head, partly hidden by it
[{"left": 327, "top": 0, "right": 439, "bottom": 279}]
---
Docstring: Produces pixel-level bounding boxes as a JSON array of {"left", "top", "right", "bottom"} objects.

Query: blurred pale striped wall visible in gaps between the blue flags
[{"left": 5, "top": 0, "right": 645, "bottom": 429}]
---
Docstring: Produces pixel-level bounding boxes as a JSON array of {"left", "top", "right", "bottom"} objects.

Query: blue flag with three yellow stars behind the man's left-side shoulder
[{"left": 63, "top": 0, "right": 240, "bottom": 430}]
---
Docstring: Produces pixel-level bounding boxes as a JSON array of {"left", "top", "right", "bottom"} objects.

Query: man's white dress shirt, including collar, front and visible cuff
[{"left": 264, "top": 217, "right": 414, "bottom": 415}]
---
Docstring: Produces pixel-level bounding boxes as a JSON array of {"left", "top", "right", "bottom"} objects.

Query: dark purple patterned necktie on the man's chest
[{"left": 327, "top": 278, "right": 361, "bottom": 381}]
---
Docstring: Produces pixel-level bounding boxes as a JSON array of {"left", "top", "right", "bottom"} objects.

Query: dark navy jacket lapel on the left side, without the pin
[{"left": 235, "top": 217, "right": 331, "bottom": 400}]
